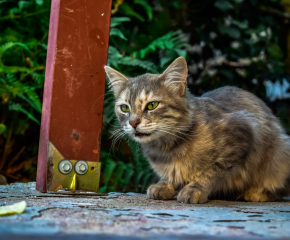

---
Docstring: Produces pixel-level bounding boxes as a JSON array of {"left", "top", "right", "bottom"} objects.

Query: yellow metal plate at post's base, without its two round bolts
[{"left": 47, "top": 142, "right": 101, "bottom": 192}]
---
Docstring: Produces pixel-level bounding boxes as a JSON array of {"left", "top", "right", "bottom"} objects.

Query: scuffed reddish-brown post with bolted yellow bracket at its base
[{"left": 36, "top": 0, "right": 111, "bottom": 192}]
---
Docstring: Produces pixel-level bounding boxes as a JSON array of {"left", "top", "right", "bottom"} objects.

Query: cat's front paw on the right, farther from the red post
[{"left": 177, "top": 185, "right": 208, "bottom": 203}]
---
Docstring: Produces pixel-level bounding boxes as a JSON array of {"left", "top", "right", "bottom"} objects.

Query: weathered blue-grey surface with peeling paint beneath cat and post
[{"left": 0, "top": 183, "right": 290, "bottom": 240}]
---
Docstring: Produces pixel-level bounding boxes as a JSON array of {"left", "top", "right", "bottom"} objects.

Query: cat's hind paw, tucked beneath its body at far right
[{"left": 244, "top": 188, "right": 276, "bottom": 202}]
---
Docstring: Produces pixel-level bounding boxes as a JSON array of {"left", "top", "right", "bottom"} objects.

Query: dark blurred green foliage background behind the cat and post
[{"left": 0, "top": 0, "right": 290, "bottom": 192}]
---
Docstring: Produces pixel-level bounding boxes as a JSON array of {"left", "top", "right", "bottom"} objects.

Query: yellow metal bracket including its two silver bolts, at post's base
[{"left": 47, "top": 142, "right": 101, "bottom": 195}]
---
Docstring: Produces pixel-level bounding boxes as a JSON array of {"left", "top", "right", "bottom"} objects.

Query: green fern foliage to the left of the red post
[{"left": 0, "top": 0, "right": 50, "bottom": 181}]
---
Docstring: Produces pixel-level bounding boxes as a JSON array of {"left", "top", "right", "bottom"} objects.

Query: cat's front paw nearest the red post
[{"left": 147, "top": 181, "right": 177, "bottom": 200}]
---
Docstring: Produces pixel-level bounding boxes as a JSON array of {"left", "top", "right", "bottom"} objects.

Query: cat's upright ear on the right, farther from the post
[{"left": 158, "top": 57, "right": 187, "bottom": 95}]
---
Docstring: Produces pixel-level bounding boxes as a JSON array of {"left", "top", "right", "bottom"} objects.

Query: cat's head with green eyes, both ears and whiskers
[{"left": 105, "top": 57, "right": 189, "bottom": 143}]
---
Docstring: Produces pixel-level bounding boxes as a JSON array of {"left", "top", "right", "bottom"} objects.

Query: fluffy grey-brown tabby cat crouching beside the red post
[{"left": 105, "top": 57, "right": 290, "bottom": 203}]
